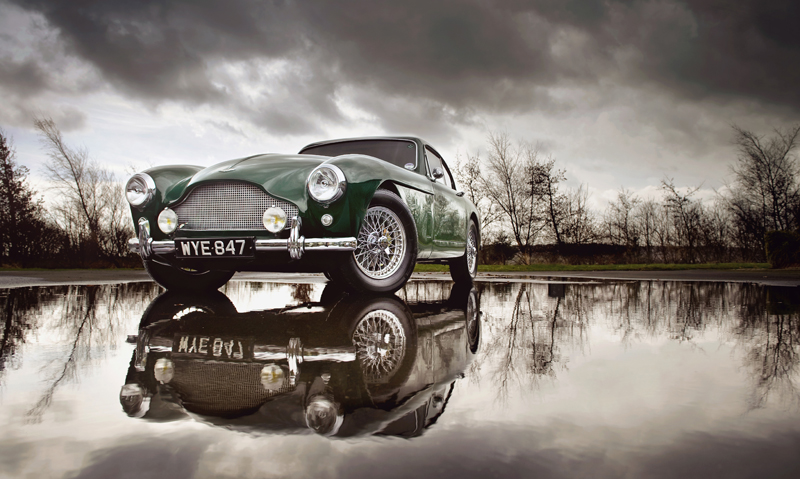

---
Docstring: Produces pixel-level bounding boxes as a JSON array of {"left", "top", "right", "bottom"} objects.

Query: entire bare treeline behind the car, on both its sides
[{"left": 0, "top": 118, "right": 800, "bottom": 267}]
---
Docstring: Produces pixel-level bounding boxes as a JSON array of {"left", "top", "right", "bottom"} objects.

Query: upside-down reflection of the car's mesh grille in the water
[{"left": 170, "top": 360, "right": 295, "bottom": 416}]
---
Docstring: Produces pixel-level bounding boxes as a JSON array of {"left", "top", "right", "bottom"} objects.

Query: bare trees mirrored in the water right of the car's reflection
[{"left": 475, "top": 281, "right": 800, "bottom": 408}]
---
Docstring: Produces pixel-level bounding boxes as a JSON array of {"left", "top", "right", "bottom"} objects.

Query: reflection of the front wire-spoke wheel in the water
[{"left": 353, "top": 309, "right": 406, "bottom": 384}]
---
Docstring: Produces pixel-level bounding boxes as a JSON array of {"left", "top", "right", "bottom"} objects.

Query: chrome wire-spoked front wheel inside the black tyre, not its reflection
[{"left": 353, "top": 206, "right": 407, "bottom": 279}]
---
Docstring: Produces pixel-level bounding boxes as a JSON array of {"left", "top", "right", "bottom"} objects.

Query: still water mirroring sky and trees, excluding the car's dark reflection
[{"left": 0, "top": 281, "right": 800, "bottom": 478}]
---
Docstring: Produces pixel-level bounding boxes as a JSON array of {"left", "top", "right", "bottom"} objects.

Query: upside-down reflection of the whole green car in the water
[{"left": 120, "top": 285, "right": 480, "bottom": 437}]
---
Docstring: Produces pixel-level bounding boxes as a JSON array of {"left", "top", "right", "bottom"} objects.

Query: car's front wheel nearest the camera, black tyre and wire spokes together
[{"left": 330, "top": 190, "right": 417, "bottom": 293}]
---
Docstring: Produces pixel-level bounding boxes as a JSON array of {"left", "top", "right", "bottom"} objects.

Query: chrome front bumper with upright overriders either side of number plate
[{"left": 128, "top": 216, "right": 356, "bottom": 260}]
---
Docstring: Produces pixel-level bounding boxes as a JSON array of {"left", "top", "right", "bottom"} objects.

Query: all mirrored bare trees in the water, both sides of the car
[{"left": 0, "top": 281, "right": 800, "bottom": 422}]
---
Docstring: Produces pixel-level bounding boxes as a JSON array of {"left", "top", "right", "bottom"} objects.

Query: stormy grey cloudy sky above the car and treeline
[{"left": 0, "top": 0, "right": 800, "bottom": 202}]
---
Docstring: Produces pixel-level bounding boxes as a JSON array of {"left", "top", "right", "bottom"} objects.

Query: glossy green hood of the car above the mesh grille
[{"left": 170, "top": 154, "right": 329, "bottom": 206}]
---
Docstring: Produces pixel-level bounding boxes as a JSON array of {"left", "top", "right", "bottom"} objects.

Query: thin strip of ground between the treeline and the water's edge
[{"left": 0, "top": 269, "right": 800, "bottom": 288}]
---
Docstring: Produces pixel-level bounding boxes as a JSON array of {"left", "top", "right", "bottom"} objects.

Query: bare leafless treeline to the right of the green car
[{"left": 455, "top": 125, "right": 800, "bottom": 266}]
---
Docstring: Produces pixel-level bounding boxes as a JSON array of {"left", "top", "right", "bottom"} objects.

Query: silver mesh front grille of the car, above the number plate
[{"left": 175, "top": 181, "right": 297, "bottom": 231}]
